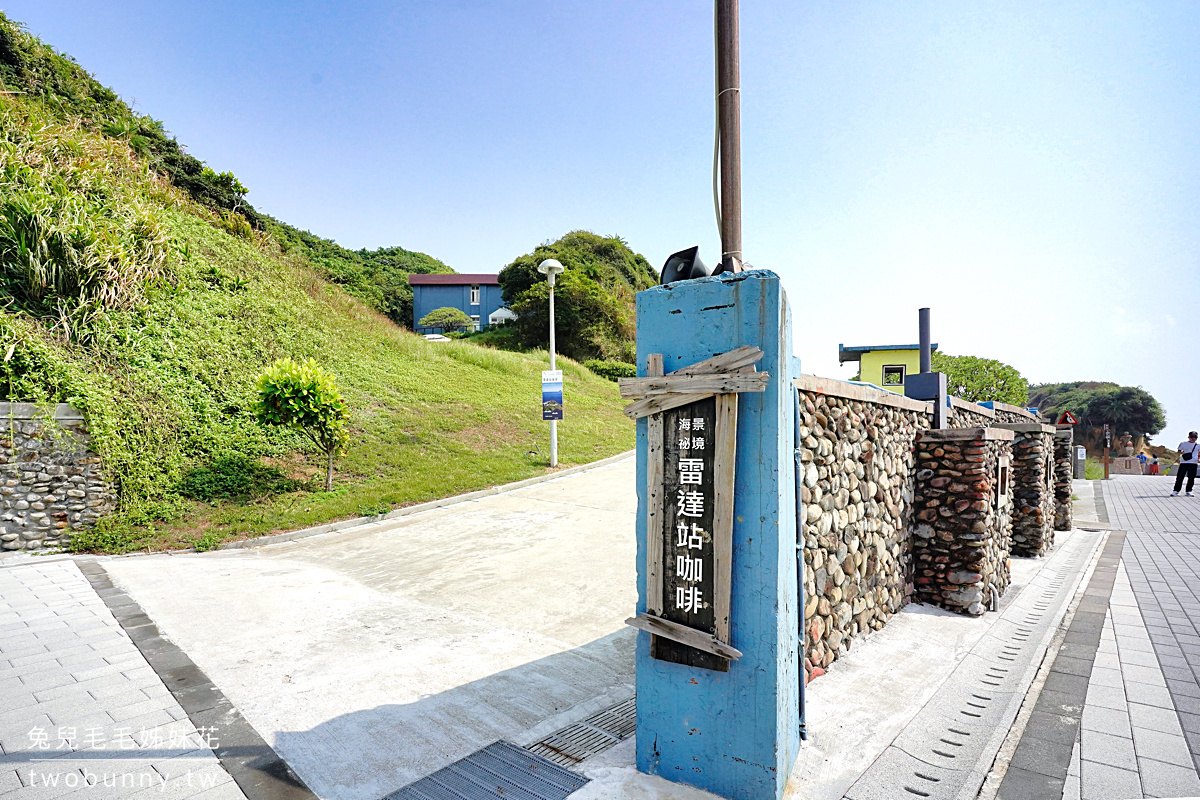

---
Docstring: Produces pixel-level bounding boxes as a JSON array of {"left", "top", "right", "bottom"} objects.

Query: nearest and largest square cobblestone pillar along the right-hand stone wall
[{"left": 912, "top": 427, "right": 1013, "bottom": 615}]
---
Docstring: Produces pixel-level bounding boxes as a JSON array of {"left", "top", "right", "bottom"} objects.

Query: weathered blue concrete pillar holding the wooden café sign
[{"left": 637, "top": 270, "right": 802, "bottom": 800}]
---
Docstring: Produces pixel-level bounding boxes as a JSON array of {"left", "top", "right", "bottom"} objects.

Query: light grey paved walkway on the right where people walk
[{"left": 998, "top": 475, "right": 1200, "bottom": 800}]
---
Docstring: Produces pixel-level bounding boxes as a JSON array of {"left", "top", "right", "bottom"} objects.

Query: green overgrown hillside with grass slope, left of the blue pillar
[{"left": 0, "top": 16, "right": 634, "bottom": 552}]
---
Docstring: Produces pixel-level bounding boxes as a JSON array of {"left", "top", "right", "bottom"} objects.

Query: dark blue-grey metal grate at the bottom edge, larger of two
[{"left": 384, "top": 740, "right": 588, "bottom": 800}]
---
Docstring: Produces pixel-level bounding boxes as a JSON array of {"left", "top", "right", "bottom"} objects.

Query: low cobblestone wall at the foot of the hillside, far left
[{"left": 0, "top": 403, "right": 115, "bottom": 551}]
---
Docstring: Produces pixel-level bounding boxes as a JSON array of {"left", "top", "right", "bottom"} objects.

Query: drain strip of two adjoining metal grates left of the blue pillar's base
[{"left": 384, "top": 697, "right": 637, "bottom": 800}]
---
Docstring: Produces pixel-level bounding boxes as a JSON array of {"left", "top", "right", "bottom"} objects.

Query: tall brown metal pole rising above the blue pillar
[{"left": 716, "top": 0, "right": 743, "bottom": 272}]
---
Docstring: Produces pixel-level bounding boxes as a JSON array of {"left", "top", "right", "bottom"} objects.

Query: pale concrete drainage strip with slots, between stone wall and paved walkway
[{"left": 845, "top": 529, "right": 1104, "bottom": 800}]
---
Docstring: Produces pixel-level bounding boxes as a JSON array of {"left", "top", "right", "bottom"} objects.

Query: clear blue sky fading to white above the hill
[{"left": 9, "top": 0, "right": 1200, "bottom": 445}]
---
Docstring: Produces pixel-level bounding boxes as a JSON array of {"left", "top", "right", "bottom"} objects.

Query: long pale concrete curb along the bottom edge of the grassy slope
[{"left": 0, "top": 450, "right": 636, "bottom": 570}]
